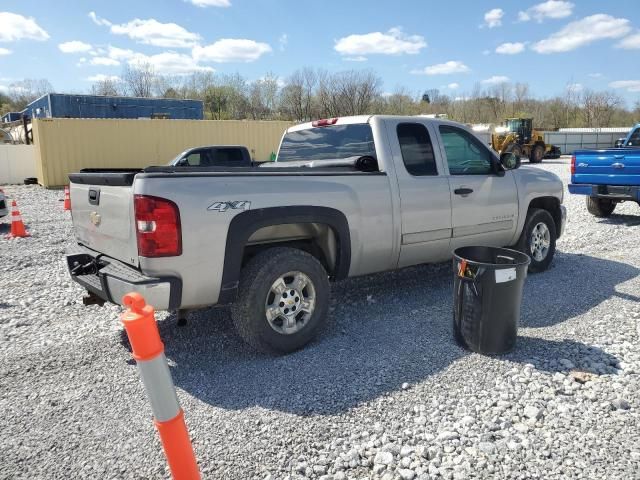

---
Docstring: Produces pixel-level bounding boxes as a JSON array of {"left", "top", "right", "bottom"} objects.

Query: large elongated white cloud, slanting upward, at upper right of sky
[{"left": 532, "top": 13, "right": 631, "bottom": 53}]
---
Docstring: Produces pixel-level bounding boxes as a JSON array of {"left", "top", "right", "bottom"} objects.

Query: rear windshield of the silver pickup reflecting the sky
[{"left": 278, "top": 123, "right": 376, "bottom": 162}]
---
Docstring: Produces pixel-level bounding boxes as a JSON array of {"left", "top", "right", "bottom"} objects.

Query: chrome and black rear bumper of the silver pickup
[{"left": 66, "top": 245, "right": 182, "bottom": 310}]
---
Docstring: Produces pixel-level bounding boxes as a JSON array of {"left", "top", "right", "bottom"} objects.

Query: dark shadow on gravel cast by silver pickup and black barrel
[{"left": 154, "top": 254, "right": 638, "bottom": 415}]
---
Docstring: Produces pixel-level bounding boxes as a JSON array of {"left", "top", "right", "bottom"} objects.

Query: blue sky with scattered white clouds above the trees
[{"left": 0, "top": 0, "right": 640, "bottom": 104}]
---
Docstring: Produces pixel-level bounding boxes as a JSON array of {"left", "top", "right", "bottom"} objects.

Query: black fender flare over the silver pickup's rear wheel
[{"left": 218, "top": 205, "right": 351, "bottom": 304}]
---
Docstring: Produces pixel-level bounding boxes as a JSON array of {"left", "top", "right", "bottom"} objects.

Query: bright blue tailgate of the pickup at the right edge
[{"left": 571, "top": 147, "right": 640, "bottom": 185}]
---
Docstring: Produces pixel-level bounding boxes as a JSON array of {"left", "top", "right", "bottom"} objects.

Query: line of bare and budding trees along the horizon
[{"left": 0, "top": 65, "right": 640, "bottom": 129}]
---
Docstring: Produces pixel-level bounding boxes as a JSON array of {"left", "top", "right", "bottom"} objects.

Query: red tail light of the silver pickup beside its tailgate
[{"left": 134, "top": 195, "right": 182, "bottom": 257}]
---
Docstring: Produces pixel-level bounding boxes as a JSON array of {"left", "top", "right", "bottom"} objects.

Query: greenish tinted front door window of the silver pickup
[{"left": 440, "top": 125, "right": 493, "bottom": 175}]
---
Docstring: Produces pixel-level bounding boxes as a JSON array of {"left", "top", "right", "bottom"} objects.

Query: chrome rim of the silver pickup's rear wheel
[{"left": 265, "top": 272, "right": 316, "bottom": 335}]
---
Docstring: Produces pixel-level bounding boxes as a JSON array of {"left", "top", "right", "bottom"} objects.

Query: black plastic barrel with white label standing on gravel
[{"left": 453, "top": 247, "right": 531, "bottom": 354}]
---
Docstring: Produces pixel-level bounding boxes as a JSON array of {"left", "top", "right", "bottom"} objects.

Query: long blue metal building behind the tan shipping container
[{"left": 20, "top": 93, "right": 204, "bottom": 120}]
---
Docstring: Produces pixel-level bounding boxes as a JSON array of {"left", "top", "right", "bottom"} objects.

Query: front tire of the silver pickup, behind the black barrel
[{"left": 515, "top": 208, "right": 557, "bottom": 273}]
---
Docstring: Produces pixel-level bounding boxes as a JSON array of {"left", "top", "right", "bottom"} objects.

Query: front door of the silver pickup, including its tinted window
[{"left": 438, "top": 124, "right": 518, "bottom": 249}]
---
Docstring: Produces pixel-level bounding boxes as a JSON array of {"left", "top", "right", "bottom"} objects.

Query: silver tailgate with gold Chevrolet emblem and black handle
[{"left": 69, "top": 173, "right": 138, "bottom": 267}]
